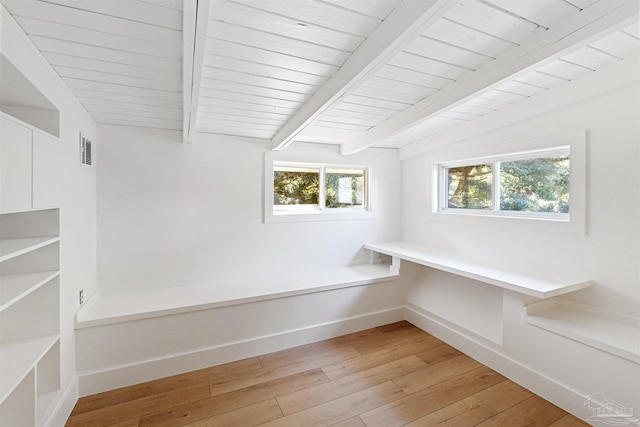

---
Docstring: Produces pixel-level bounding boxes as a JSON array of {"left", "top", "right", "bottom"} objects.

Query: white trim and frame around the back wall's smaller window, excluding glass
[{"left": 264, "top": 153, "right": 375, "bottom": 223}]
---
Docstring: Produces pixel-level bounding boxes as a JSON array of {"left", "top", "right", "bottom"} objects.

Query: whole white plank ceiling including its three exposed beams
[{"left": 1, "top": 0, "right": 640, "bottom": 154}]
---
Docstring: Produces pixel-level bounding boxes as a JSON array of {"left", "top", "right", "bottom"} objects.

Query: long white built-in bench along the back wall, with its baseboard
[{"left": 75, "top": 257, "right": 407, "bottom": 396}]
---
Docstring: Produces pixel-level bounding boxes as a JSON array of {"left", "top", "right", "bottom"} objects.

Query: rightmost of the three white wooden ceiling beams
[{"left": 341, "top": 0, "right": 639, "bottom": 155}]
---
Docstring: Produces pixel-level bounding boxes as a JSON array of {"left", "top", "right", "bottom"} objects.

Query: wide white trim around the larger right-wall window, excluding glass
[{"left": 427, "top": 132, "right": 586, "bottom": 234}]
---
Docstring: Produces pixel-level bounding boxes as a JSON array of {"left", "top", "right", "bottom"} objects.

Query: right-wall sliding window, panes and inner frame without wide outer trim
[{"left": 438, "top": 146, "right": 571, "bottom": 220}]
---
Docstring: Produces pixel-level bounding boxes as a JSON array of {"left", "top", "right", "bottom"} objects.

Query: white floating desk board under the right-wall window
[{"left": 364, "top": 241, "right": 591, "bottom": 299}]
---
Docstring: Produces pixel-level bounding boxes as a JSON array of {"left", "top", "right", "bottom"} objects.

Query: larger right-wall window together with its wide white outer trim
[{"left": 425, "top": 131, "right": 588, "bottom": 235}]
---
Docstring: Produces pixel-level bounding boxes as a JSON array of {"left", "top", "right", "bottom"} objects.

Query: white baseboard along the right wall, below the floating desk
[{"left": 405, "top": 307, "right": 590, "bottom": 420}]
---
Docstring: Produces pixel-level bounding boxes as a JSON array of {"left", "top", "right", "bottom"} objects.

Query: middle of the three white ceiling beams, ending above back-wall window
[{"left": 271, "top": 0, "right": 456, "bottom": 150}]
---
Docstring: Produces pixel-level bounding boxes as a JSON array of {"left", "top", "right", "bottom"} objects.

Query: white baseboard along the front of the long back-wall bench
[{"left": 78, "top": 307, "right": 405, "bottom": 396}]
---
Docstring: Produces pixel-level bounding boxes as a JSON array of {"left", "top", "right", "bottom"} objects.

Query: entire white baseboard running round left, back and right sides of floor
[{"left": 71, "top": 305, "right": 638, "bottom": 426}]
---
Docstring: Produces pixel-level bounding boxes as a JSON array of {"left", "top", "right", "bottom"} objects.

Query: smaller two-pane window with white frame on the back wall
[{"left": 265, "top": 161, "right": 371, "bottom": 222}]
